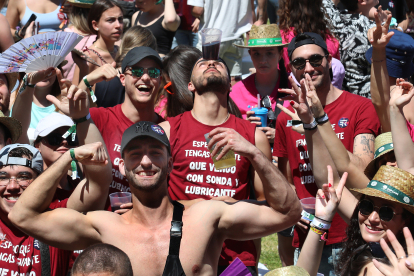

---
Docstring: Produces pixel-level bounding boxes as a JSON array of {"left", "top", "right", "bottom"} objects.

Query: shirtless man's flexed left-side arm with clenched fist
[{"left": 9, "top": 143, "right": 108, "bottom": 250}]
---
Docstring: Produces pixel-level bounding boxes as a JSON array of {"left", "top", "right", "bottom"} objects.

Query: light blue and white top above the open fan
[{"left": 20, "top": 0, "right": 61, "bottom": 33}]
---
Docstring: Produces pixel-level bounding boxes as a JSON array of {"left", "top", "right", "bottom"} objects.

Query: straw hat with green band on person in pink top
[{"left": 233, "top": 24, "right": 289, "bottom": 48}]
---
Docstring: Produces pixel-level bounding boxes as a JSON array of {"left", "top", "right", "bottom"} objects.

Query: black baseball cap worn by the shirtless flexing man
[{"left": 121, "top": 121, "right": 171, "bottom": 157}]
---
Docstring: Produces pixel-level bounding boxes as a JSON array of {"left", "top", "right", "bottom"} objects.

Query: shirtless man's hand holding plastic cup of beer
[{"left": 208, "top": 127, "right": 257, "bottom": 160}]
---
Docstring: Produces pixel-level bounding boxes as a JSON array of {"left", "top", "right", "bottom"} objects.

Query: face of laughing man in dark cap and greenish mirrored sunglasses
[{"left": 120, "top": 58, "right": 162, "bottom": 108}]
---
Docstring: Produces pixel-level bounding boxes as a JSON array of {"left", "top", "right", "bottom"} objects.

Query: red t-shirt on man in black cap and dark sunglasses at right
[{"left": 273, "top": 91, "right": 380, "bottom": 247}]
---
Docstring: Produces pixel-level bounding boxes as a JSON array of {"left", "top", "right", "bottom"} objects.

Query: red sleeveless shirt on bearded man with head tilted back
[{"left": 168, "top": 111, "right": 257, "bottom": 266}]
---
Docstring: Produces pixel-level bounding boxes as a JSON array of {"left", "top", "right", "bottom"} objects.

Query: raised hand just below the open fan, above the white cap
[{"left": 46, "top": 69, "right": 89, "bottom": 119}]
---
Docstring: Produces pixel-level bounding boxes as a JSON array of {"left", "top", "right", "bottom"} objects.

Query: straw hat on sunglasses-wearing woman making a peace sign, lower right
[{"left": 351, "top": 166, "right": 414, "bottom": 214}]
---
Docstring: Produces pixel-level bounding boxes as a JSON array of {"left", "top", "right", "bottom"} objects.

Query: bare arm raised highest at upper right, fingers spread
[{"left": 368, "top": 13, "right": 394, "bottom": 133}]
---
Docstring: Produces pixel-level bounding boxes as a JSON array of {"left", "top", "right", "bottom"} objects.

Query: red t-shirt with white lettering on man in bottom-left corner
[{"left": 0, "top": 200, "right": 72, "bottom": 276}]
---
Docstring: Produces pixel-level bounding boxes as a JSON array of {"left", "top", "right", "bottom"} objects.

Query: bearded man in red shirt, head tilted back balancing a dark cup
[{"left": 161, "top": 59, "right": 271, "bottom": 275}]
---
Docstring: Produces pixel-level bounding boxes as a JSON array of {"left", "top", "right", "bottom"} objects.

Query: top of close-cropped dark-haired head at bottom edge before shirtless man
[{"left": 72, "top": 243, "right": 133, "bottom": 276}]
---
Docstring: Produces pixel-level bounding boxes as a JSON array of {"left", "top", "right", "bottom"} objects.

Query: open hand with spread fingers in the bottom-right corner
[{"left": 373, "top": 227, "right": 414, "bottom": 276}]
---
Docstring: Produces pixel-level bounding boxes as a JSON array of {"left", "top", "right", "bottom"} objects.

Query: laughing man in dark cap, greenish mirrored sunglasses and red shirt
[{"left": 90, "top": 47, "right": 164, "bottom": 193}]
